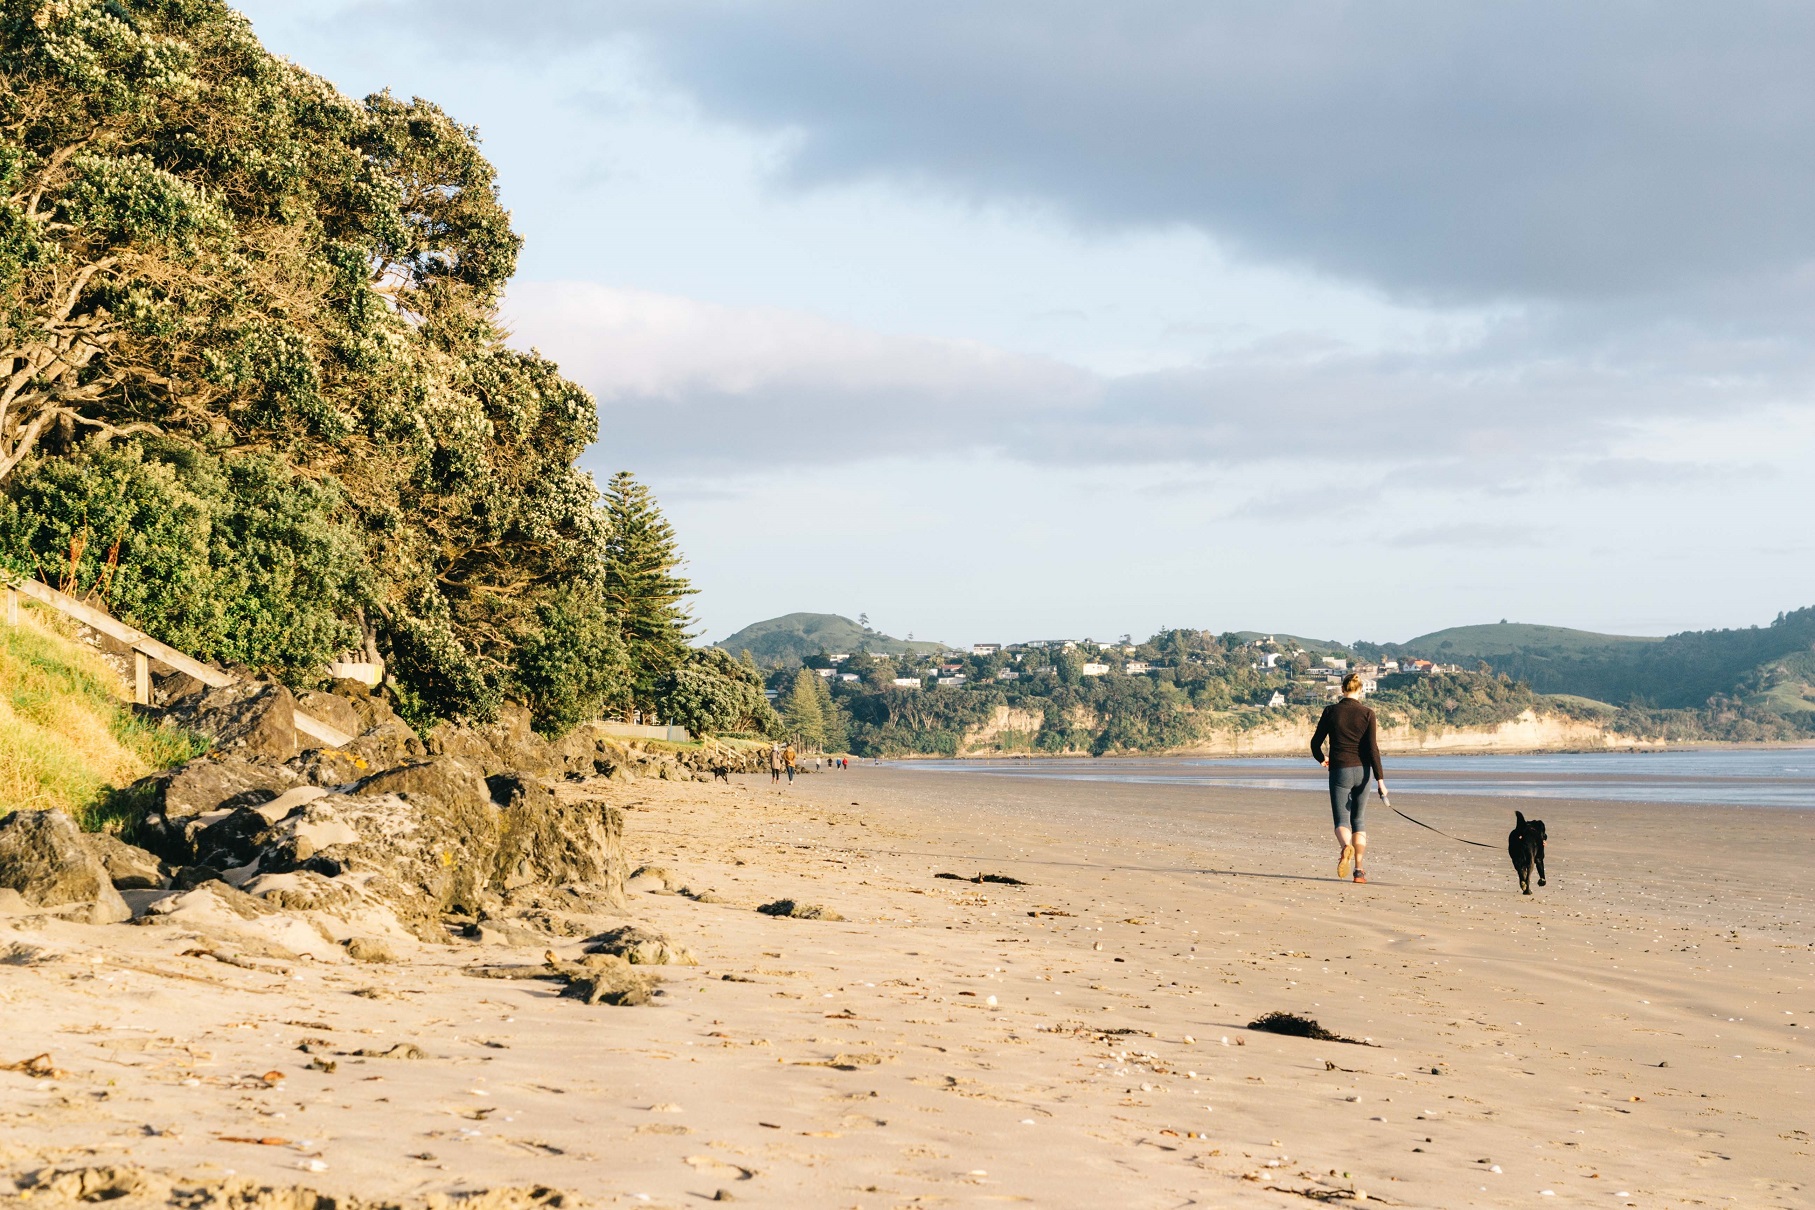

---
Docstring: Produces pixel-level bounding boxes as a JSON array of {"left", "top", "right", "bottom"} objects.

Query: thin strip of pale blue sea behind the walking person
[{"left": 893, "top": 747, "right": 1815, "bottom": 811}]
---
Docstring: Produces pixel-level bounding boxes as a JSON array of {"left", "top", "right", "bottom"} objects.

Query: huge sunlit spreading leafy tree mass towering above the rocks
[{"left": 0, "top": 0, "right": 667, "bottom": 729}]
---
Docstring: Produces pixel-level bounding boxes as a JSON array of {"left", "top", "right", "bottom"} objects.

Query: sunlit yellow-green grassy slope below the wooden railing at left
[{"left": 0, "top": 608, "right": 200, "bottom": 829}]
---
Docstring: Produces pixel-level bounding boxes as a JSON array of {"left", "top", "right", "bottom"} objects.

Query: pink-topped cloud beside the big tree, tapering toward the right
[{"left": 505, "top": 283, "right": 1102, "bottom": 464}]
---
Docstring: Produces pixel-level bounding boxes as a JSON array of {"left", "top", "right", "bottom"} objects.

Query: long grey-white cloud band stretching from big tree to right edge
[{"left": 506, "top": 283, "right": 1815, "bottom": 471}]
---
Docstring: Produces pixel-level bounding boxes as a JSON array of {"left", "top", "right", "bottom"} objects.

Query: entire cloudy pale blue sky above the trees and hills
[{"left": 238, "top": 0, "right": 1815, "bottom": 642}]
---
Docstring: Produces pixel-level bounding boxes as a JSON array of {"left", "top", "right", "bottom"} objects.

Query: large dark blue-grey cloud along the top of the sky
[{"left": 394, "top": 0, "right": 1815, "bottom": 301}]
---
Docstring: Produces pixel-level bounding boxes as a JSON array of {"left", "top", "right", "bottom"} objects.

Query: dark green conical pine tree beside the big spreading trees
[{"left": 604, "top": 470, "right": 697, "bottom": 709}]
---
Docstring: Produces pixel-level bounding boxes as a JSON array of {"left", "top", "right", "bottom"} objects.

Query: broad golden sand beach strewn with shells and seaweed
[{"left": 0, "top": 767, "right": 1815, "bottom": 1208}]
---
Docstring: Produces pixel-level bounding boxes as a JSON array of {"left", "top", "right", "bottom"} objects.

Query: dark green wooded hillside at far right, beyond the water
[{"left": 1385, "top": 606, "right": 1815, "bottom": 713}]
